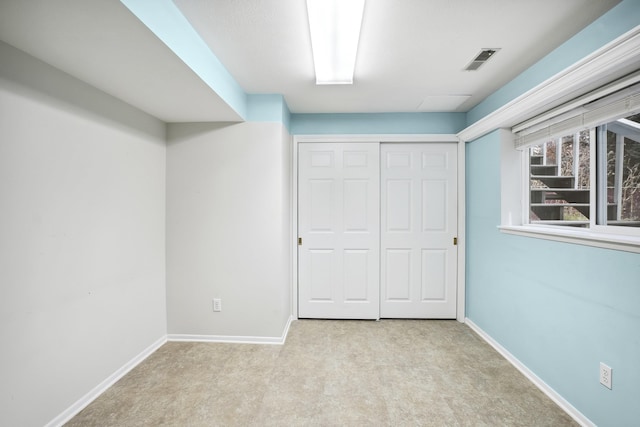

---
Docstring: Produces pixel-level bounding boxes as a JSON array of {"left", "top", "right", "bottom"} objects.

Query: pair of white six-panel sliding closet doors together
[{"left": 298, "top": 142, "right": 457, "bottom": 319}]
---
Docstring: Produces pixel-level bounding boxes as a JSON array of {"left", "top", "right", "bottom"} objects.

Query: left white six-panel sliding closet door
[{"left": 298, "top": 143, "right": 380, "bottom": 319}]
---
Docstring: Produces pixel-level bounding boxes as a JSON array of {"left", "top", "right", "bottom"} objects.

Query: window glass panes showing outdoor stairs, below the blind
[{"left": 528, "top": 114, "right": 640, "bottom": 228}]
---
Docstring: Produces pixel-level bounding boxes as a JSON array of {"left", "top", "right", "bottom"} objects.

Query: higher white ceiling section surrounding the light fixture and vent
[{"left": 174, "top": 0, "right": 618, "bottom": 113}]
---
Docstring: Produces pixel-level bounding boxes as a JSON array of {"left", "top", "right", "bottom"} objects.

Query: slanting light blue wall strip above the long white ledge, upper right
[{"left": 467, "top": 0, "right": 640, "bottom": 125}]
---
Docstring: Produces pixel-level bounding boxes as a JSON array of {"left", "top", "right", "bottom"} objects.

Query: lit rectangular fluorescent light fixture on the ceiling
[{"left": 307, "top": 0, "right": 365, "bottom": 85}]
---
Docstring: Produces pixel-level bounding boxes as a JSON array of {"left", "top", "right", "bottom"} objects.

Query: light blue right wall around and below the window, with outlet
[{"left": 465, "top": 132, "right": 640, "bottom": 427}]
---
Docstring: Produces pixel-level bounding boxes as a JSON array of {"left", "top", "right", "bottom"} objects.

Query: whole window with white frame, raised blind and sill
[{"left": 508, "top": 82, "right": 640, "bottom": 252}]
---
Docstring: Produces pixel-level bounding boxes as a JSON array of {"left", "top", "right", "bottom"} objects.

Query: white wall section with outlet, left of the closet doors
[{"left": 167, "top": 123, "right": 291, "bottom": 338}]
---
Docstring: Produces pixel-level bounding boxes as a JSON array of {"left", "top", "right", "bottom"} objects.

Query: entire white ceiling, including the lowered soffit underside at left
[{"left": 0, "top": 0, "right": 619, "bottom": 122}]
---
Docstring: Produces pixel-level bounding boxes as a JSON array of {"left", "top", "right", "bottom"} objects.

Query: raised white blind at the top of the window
[{"left": 512, "top": 80, "right": 640, "bottom": 150}]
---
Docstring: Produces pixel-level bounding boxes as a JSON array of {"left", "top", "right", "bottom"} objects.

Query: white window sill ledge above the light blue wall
[{"left": 498, "top": 225, "right": 640, "bottom": 253}]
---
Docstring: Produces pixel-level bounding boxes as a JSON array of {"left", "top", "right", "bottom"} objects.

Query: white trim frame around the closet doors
[{"left": 291, "top": 134, "right": 466, "bottom": 323}]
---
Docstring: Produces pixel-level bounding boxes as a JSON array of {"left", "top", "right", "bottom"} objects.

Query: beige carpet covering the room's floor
[{"left": 67, "top": 320, "right": 577, "bottom": 427}]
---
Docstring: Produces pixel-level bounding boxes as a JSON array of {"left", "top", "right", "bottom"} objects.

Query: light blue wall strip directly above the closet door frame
[{"left": 291, "top": 113, "right": 465, "bottom": 135}]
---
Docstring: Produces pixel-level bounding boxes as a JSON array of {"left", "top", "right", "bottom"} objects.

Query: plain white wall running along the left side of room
[{"left": 0, "top": 43, "right": 166, "bottom": 426}]
